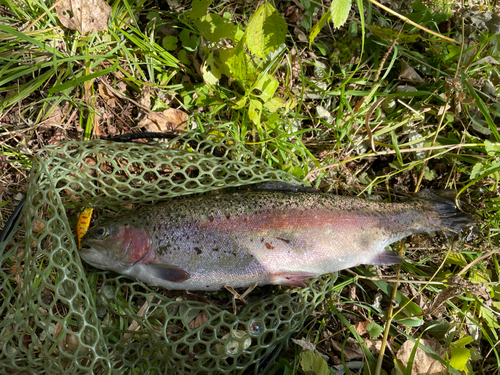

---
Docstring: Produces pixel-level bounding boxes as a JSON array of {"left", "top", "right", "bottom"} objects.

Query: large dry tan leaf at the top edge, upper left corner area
[{"left": 56, "top": 0, "right": 111, "bottom": 34}]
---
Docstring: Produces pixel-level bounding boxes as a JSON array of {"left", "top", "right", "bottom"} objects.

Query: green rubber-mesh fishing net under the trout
[{"left": 0, "top": 134, "right": 335, "bottom": 374}]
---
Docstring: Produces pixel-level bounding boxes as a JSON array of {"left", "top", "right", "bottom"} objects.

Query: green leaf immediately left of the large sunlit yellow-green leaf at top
[{"left": 193, "top": 13, "right": 243, "bottom": 42}]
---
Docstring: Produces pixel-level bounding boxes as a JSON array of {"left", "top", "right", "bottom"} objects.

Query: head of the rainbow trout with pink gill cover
[{"left": 79, "top": 222, "right": 154, "bottom": 272}]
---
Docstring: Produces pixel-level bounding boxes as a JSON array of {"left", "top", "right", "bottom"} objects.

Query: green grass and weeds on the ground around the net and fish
[{"left": 0, "top": 0, "right": 500, "bottom": 374}]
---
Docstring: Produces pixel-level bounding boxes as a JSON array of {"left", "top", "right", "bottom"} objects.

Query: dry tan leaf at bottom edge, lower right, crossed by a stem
[{"left": 396, "top": 339, "right": 448, "bottom": 375}]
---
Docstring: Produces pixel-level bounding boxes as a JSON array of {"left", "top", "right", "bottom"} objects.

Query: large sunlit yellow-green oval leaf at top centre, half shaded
[{"left": 245, "top": 2, "right": 287, "bottom": 57}]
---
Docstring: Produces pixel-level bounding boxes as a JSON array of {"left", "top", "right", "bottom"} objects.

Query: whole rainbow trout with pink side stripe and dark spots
[{"left": 79, "top": 187, "right": 471, "bottom": 291}]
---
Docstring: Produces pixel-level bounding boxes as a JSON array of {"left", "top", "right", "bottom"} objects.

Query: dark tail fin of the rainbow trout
[{"left": 416, "top": 189, "right": 474, "bottom": 236}]
